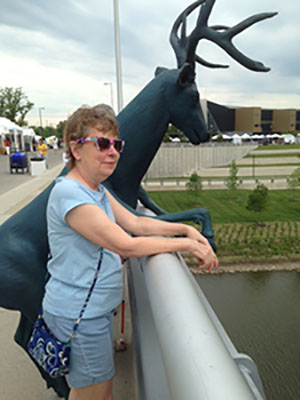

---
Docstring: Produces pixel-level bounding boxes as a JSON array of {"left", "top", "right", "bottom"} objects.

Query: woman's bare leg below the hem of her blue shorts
[{"left": 68, "top": 379, "right": 113, "bottom": 400}]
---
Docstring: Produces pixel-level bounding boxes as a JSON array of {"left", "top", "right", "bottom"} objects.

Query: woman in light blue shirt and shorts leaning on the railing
[{"left": 43, "top": 107, "right": 217, "bottom": 400}]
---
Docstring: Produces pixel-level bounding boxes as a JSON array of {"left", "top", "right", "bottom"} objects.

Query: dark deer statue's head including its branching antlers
[{"left": 156, "top": 0, "right": 277, "bottom": 144}]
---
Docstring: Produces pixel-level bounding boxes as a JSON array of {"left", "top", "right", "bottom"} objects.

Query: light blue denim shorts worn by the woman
[{"left": 43, "top": 310, "right": 115, "bottom": 388}]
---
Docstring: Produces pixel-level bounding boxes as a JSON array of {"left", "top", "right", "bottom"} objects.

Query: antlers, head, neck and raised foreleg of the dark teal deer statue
[{"left": 104, "top": 0, "right": 277, "bottom": 242}]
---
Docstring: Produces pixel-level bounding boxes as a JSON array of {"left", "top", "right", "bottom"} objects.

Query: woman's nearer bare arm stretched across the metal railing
[{"left": 66, "top": 204, "right": 217, "bottom": 271}]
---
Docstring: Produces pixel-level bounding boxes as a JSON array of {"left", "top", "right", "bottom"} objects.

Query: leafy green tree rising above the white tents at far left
[{"left": 0, "top": 87, "right": 34, "bottom": 126}]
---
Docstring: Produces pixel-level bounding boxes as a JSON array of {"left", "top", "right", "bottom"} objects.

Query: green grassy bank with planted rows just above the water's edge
[{"left": 151, "top": 190, "right": 300, "bottom": 264}]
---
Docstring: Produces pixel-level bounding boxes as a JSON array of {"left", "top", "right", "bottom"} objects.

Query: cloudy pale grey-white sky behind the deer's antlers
[{"left": 0, "top": 0, "right": 300, "bottom": 124}]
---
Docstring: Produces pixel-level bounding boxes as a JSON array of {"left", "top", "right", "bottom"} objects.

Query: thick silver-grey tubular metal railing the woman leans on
[{"left": 128, "top": 253, "right": 265, "bottom": 400}]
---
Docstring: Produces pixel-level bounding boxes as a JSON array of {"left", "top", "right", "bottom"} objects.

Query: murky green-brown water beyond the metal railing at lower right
[{"left": 195, "top": 272, "right": 300, "bottom": 400}]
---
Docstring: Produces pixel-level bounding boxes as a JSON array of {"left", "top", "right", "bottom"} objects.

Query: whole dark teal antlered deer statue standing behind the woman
[{"left": 0, "top": 0, "right": 276, "bottom": 395}]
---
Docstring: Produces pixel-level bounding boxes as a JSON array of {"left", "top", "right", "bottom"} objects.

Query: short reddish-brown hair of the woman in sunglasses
[{"left": 64, "top": 104, "right": 119, "bottom": 169}]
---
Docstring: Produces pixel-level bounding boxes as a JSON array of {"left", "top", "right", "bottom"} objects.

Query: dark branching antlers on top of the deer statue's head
[{"left": 170, "top": 0, "right": 277, "bottom": 72}]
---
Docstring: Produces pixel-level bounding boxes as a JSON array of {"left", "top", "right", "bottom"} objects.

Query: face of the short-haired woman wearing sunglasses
[{"left": 76, "top": 128, "right": 120, "bottom": 183}]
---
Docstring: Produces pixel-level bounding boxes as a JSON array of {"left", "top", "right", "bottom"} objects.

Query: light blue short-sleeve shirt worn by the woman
[{"left": 43, "top": 177, "right": 123, "bottom": 318}]
